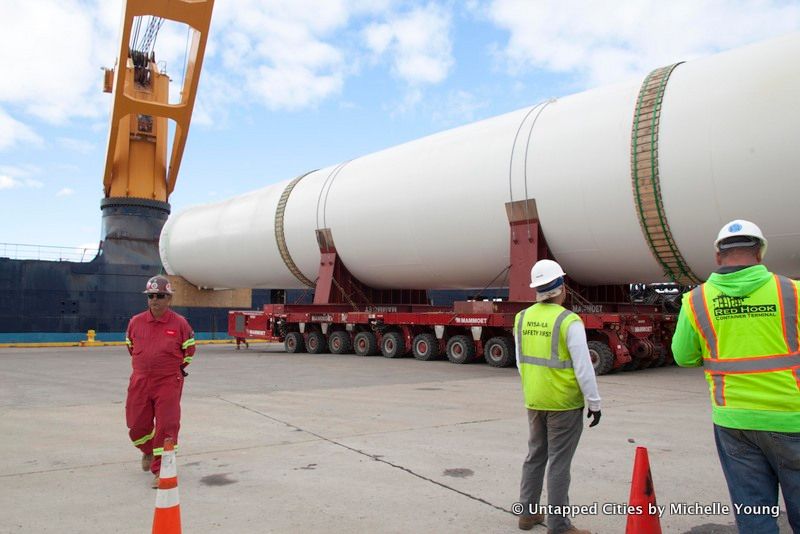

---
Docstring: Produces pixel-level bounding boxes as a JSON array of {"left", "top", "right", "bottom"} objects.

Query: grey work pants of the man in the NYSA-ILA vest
[{"left": 519, "top": 408, "right": 583, "bottom": 532}]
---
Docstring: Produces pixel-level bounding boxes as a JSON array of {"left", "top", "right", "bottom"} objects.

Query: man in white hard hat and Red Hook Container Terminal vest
[{"left": 672, "top": 220, "right": 800, "bottom": 534}]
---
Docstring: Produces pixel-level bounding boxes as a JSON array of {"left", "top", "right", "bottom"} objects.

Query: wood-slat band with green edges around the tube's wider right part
[{"left": 631, "top": 62, "right": 700, "bottom": 284}]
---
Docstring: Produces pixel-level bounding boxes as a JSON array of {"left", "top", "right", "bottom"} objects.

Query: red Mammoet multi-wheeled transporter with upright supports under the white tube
[{"left": 228, "top": 203, "right": 676, "bottom": 374}]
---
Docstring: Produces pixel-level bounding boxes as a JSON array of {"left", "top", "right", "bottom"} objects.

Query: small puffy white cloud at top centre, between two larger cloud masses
[{"left": 363, "top": 3, "right": 453, "bottom": 86}]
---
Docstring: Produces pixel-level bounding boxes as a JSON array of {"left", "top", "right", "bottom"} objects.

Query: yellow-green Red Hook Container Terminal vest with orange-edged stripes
[{"left": 685, "top": 275, "right": 800, "bottom": 432}]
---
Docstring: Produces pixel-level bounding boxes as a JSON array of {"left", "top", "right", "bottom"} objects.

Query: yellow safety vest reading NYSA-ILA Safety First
[{"left": 514, "top": 303, "right": 583, "bottom": 411}]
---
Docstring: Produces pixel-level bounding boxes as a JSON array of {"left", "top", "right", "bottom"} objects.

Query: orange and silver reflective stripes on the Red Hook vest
[{"left": 689, "top": 275, "right": 800, "bottom": 406}]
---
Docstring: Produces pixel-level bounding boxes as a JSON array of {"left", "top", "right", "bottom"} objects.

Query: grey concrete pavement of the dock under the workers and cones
[{"left": 0, "top": 345, "right": 790, "bottom": 534}]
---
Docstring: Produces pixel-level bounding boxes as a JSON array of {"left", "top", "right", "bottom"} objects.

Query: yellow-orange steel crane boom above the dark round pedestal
[{"left": 103, "top": 0, "right": 214, "bottom": 203}]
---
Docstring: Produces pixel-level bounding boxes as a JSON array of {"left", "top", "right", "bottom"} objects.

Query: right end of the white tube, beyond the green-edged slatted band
[{"left": 659, "top": 34, "right": 800, "bottom": 278}]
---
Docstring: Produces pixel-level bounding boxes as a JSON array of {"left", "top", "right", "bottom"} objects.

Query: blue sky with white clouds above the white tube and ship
[{"left": 0, "top": 0, "right": 800, "bottom": 260}]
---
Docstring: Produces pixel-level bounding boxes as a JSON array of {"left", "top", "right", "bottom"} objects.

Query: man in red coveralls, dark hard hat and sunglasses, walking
[{"left": 125, "top": 276, "right": 195, "bottom": 488}]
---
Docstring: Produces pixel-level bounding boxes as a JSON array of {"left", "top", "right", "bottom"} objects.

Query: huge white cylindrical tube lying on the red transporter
[{"left": 161, "top": 34, "right": 800, "bottom": 289}]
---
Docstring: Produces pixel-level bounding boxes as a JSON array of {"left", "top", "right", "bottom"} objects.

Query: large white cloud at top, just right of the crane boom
[{"left": 203, "top": 0, "right": 394, "bottom": 113}]
